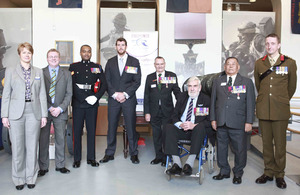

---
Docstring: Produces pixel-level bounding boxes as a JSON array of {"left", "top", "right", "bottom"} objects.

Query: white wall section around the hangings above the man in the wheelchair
[{"left": 159, "top": 0, "right": 222, "bottom": 84}]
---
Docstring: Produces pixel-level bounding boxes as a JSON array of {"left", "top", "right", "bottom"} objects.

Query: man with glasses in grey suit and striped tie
[{"left": 38, "top": 49, "right": 72, "bottom": 177}]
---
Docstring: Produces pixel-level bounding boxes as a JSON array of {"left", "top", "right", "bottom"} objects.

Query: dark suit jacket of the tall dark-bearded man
[{"left": 105, "top": 55, "right": 141, "bottom": 99}]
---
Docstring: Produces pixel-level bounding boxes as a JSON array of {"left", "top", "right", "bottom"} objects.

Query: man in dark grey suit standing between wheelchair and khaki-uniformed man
[{"left": 210, "top": 57, "right": 255, "bottom": 184}]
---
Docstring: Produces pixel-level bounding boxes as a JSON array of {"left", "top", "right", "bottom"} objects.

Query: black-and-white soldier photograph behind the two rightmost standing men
[{"left": 221, "top": 11, "right": 275, "bottom": 79}]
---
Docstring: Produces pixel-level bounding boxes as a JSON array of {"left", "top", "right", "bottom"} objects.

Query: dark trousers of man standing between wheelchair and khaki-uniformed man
[{"left": 217, "top": 126, "right": 247, "bottom": 177}]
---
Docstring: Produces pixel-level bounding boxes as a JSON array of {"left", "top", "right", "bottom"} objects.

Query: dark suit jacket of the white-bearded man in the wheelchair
[{"left": 172, "top": 91, "right": 211, "bottom": 128}]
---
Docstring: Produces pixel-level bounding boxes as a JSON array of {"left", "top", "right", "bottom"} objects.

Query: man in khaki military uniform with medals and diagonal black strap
[{"left": 254, "top": 34, "right": 297, "bottom": 189}]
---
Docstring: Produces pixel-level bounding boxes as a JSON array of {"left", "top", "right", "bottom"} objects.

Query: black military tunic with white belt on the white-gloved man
[{"left": 69, "top": 60, "right": 107, "bottom": 108}]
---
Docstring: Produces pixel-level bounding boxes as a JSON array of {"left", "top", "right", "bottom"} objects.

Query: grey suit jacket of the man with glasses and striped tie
[{"left": 43, "top": 66, "right": 72, "bottom": 120}]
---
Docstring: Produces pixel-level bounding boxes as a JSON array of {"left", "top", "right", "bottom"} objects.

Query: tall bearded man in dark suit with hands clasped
[{"left": 100, "top": 38, "right": 141, "bottom": 164}]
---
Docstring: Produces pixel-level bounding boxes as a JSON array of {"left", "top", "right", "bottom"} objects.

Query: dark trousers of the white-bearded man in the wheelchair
[{"left": 164, "top": 123, "right": 207, "bottom": 156}]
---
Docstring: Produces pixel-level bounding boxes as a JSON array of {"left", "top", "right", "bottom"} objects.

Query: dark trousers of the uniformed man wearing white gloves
[{"left": 73, "top": 107, "right": 98, "bottom": 161}]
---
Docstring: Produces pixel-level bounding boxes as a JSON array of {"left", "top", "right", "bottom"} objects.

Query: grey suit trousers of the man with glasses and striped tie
[{"left": 39, "top": 116, "right": 67, "bottom": 170}]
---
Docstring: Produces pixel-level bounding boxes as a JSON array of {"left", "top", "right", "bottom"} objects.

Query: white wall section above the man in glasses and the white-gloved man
[{"left": 32, "top": 0, "right": 98, "bottom": 68}]
